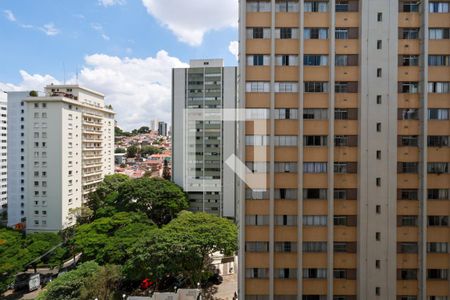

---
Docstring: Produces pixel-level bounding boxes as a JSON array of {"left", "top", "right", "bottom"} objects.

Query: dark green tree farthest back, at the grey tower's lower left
[{"left": 117, "top": 177, "right": 189, "bottom": 226}]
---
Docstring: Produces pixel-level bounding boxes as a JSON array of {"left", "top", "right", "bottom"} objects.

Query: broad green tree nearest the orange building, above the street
[{"left": 124, "top": 212, "right": 238, "bottom": 288}]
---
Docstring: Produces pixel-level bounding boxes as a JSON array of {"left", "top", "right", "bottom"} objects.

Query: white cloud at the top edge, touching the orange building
[{"left": 142, "top": 0, "right": 238, "bottom": 46}]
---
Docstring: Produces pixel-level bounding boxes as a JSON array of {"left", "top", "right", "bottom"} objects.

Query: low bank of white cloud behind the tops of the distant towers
[{"left": 0, "top": 50, "right": 188, "bottom": 130}]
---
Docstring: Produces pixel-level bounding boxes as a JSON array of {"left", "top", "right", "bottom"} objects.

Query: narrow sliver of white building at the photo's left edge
[{"left": 0, "top": 91, "right": 8, "bottom": 211}]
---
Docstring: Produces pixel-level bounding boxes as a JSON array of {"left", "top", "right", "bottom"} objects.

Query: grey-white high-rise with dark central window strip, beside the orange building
[{"left": 172, "top": 59, "right": 237, "bottom": 219}]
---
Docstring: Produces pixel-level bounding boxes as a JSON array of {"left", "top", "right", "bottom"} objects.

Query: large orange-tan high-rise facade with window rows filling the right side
[{"left": 239, "top": 0, "right": 450, "bottom": 300}]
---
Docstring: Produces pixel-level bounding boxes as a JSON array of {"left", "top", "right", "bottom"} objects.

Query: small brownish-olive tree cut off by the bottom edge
[{"left": 80, "top": 265, "right": 122, "bottom": 300}]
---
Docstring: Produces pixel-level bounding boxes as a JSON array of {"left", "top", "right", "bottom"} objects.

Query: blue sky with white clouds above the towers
[{"left": 0, "top": 0, "right": 238, "bottom": 129}]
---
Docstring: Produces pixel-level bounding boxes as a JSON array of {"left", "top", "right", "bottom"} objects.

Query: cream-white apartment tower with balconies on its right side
[{"left": 10, "top": 85, "right": 114, "bottom": 232}]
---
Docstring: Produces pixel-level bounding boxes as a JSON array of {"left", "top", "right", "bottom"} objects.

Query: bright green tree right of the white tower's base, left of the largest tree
[{"left": 70, "top": 212, "right": 156, "bottom": 265}]
